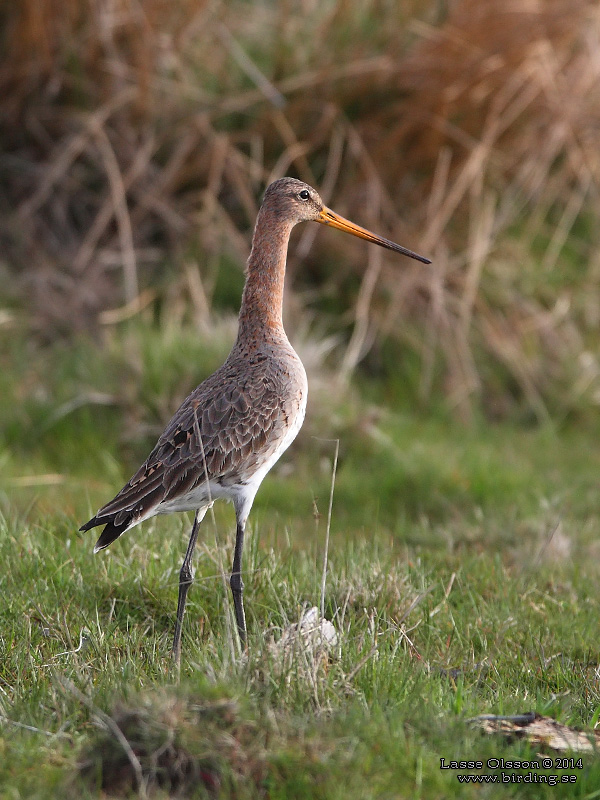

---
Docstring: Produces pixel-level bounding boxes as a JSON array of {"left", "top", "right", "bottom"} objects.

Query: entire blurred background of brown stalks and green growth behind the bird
[{"left": 0, "top": 0, "right": 600, "bottom": 500}]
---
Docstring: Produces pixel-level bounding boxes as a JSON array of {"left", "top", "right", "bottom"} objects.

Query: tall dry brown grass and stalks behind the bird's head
[{"left": 0, "top": 0, "right": 600, "bottom": 419}]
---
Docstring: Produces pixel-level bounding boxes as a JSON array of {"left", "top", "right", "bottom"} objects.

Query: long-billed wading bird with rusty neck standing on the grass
[{"left": 80, "top": 178, "right": 431, "bottom": 664}]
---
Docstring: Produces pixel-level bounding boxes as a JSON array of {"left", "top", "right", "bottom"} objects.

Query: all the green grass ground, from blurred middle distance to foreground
[{"left": 0, "top": 318, "right": 600, "bottom": 800}]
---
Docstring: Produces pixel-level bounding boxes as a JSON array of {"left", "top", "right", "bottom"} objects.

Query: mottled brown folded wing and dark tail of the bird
[{"left": 81, "top": 354, "right": 302, "bottom": 548}]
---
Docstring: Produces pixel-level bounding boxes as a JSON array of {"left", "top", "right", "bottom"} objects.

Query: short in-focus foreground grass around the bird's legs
[{"left": 0, "top": 494, "right": 600, "bottom": 797}]
